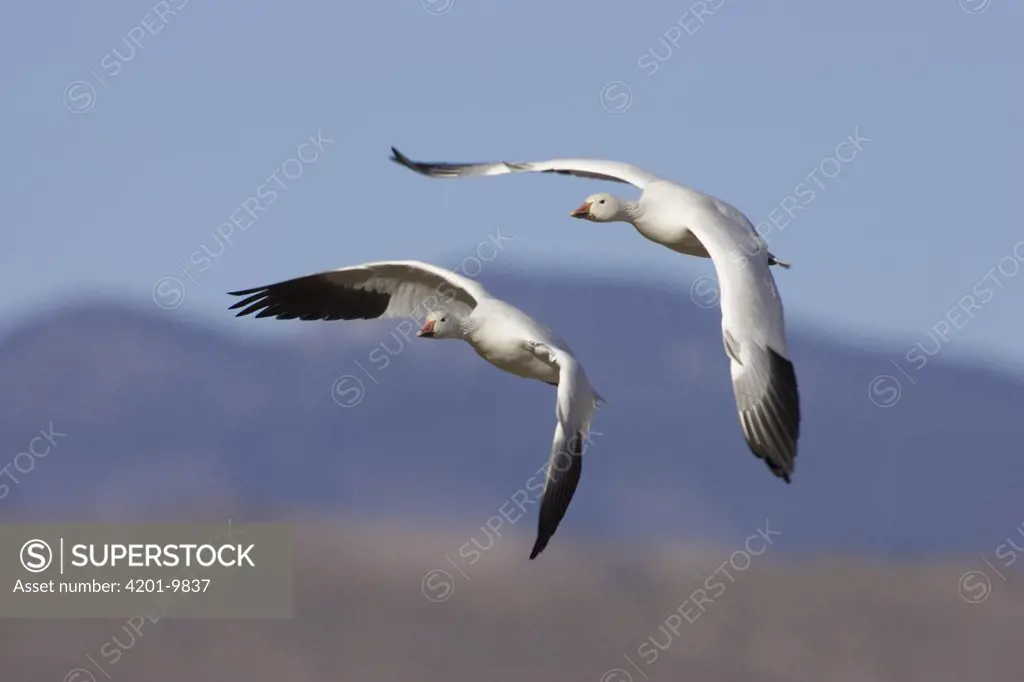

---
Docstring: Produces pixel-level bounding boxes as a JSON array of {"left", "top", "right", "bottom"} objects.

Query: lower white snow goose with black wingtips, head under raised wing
[{"left": 228, "top": 260, "right": 604, "bottom": 559}]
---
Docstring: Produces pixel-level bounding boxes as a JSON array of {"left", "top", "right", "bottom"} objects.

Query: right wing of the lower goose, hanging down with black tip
[{"left": 526, "top": 341, "right": 596, "bottom": 559}]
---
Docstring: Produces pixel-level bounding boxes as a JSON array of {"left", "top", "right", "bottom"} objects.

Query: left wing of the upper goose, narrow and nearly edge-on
[{"left": 391, "top": 146, "right": 662, "bottom": 189}]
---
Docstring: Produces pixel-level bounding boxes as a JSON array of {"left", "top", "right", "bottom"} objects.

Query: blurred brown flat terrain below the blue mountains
[{"left": 0, "top": 521, "right": 1024, "bottom": 682}]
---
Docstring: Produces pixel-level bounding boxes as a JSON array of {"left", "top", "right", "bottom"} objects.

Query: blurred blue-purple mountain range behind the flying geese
[{"left": 0, "top": 272, "right": 1024, "bottom": 553}]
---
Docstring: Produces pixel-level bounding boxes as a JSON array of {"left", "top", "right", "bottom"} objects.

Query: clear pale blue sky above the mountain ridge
[{"left": 0, "top": 0, "right": 1024, "bottom": 371}]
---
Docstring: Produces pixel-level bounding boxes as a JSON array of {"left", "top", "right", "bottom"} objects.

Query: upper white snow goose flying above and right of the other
[{"left": 391, "top": 147, "right": 800, "bottom": 483}]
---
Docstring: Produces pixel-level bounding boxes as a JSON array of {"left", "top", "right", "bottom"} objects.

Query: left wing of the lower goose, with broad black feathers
[{"left": 228, "top": 260, "right": 488, "bottom": 319}]
